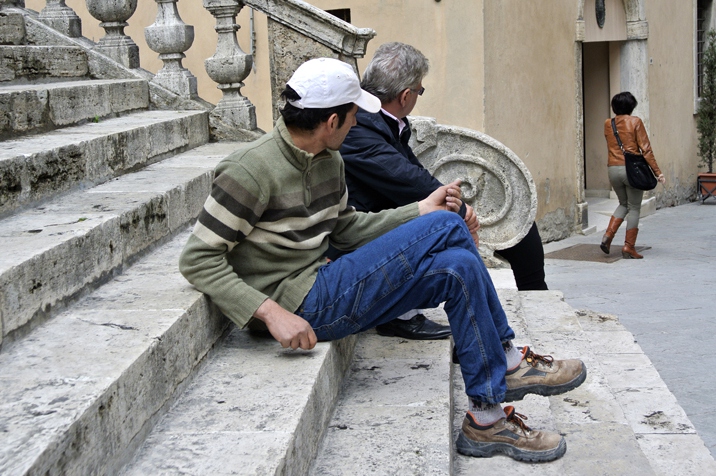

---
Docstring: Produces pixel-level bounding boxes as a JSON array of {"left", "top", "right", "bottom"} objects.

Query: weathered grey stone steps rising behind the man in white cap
[{"left": 0, "top": 5, "right": 241, "bottom": 475}]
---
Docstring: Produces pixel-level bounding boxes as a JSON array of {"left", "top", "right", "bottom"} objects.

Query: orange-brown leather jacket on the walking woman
[{"left": 604, "top": 115, "right": 661, "bottom": 177}]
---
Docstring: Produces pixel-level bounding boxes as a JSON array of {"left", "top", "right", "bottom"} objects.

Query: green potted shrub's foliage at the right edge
[{"left": 696, "top": 30, "right": 716, "bottom": 173}]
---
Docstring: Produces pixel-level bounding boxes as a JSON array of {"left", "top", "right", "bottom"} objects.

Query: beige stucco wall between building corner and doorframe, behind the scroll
[{"left": 485, "top": 0, "right": 582, "bottom": 239}]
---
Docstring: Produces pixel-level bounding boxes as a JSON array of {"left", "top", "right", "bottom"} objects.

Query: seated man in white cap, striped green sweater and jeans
[{"left": 179, "top": 58, "right": 586, "bottom": 461}]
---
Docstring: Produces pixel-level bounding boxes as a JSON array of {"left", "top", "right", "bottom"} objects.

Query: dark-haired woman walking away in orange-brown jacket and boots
[{"left": 600, "top": 91, "right": 666, "bottom": 259}]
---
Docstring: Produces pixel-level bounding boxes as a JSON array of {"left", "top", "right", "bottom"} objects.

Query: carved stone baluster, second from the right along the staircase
[{"left": 144, "top": 0, "right": 197, "bottom": 99}]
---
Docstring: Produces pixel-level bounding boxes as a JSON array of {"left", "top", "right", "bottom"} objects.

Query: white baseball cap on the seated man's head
[{"left": 287, "top": 58, "right": 380, "bottom": 112}]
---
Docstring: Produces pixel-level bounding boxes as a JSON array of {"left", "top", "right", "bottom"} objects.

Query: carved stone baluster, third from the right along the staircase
[{"left": 86, "top": 0, "right": 139, "bottom": 68}]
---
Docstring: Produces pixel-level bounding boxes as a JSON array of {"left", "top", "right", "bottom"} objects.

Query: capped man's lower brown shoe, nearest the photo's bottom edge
[{"left": 457, "top": 406, "right": 567, "bottom": 463}]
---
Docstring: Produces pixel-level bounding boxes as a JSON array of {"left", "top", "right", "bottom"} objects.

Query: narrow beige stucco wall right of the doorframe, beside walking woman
[{"left": 646, "top": 0, "right": 699, "bottom": 206}]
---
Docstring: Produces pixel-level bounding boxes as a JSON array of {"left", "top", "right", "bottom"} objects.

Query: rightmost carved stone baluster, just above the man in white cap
[{"left": 204, "top": 0, "right": 257, "bottom": 139}]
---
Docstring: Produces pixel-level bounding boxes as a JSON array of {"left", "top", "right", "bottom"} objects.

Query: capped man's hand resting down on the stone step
[{"left": 254, "top": 299, "right": 318, "bottom": 350}]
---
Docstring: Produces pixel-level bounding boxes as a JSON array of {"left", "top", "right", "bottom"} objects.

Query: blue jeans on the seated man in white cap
[{"left": 296, "top": 212, "right": 515, "bottom": 403}]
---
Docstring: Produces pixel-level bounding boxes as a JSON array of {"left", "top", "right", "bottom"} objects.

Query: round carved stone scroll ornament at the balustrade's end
[{"left": 410, "top": 117, "right": 537, "bottom": 255}]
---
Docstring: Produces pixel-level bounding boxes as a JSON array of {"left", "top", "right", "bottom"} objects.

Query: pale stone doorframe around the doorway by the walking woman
[{"left": 574, "top": 0, "right": 649, "bottom": 233}]
